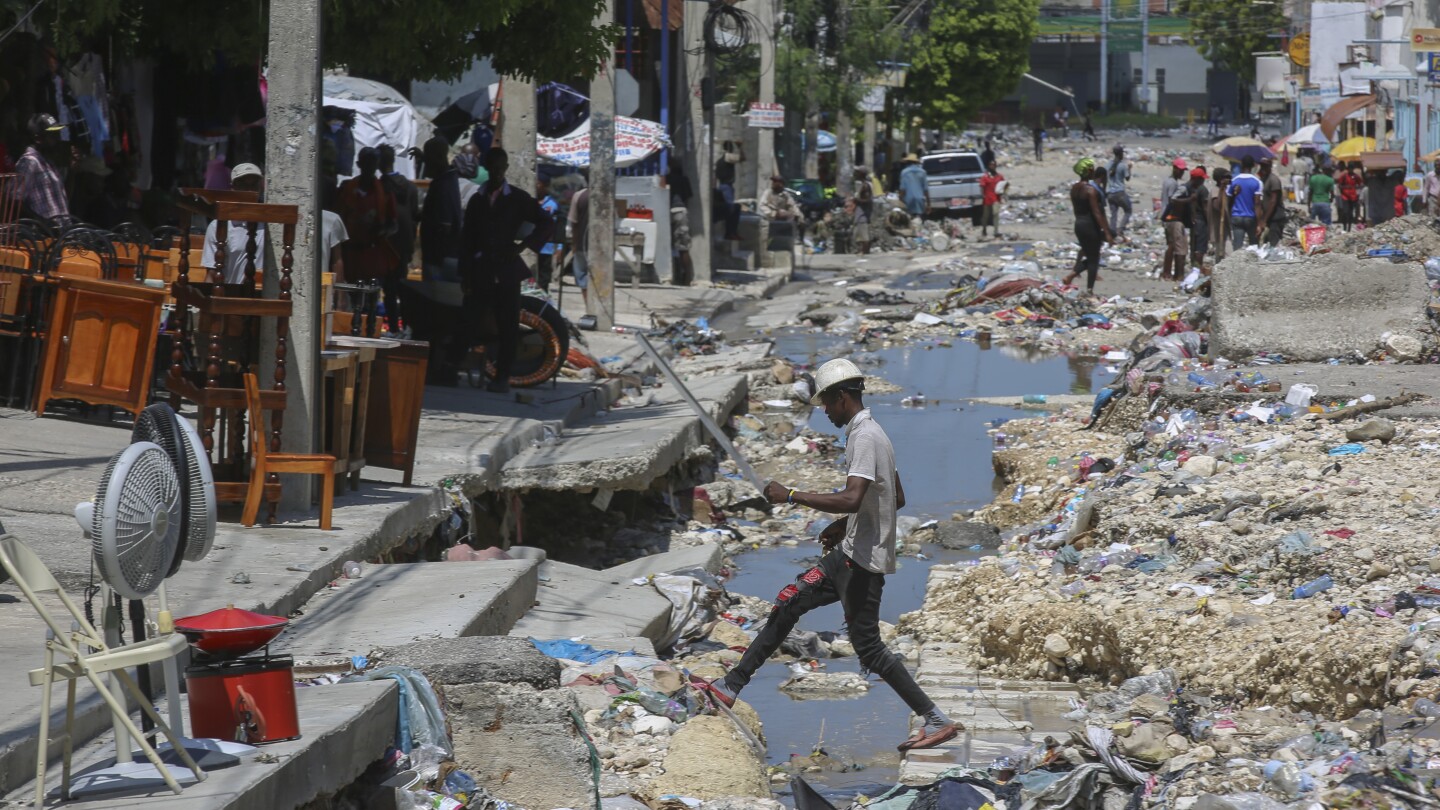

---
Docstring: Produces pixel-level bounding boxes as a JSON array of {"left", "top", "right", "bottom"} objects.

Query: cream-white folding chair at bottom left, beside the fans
[{"left": 0, "top": 535, "right": 204, "bottom": 809}]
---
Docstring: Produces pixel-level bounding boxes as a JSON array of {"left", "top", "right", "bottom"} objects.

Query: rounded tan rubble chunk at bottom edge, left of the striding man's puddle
[{"left": 648, "top": 715, "right": 770, "bottom": 807}]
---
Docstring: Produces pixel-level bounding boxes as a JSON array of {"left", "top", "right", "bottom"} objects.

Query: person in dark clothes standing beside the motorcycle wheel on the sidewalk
[{"left": 462, "top": 147, "right": 554, "bottom": 393}]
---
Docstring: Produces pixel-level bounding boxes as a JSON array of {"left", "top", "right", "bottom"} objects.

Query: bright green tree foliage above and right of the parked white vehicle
[{"left": 904, "top": 0, "right": 1040, "bottom": 128}]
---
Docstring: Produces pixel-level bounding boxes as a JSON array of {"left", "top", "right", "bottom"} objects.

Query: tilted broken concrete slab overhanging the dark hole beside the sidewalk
[{"left": 500, "top": 375, "right": 747, "bottom": 491}]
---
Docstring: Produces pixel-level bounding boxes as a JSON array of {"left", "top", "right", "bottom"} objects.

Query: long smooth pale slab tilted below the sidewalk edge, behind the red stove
[{"left": 274, "top": 559, "right": 540, "bottom": 659}]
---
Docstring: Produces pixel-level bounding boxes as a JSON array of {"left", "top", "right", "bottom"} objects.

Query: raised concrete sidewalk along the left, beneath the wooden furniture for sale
[{"left": 0, "top": 265, "right": 785, "bottom": 796}]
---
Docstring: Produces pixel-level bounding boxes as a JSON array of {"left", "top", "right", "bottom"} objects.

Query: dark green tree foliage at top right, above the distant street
[{"left": 1179, "top": 0, "right": 1289, "bottom": 85}]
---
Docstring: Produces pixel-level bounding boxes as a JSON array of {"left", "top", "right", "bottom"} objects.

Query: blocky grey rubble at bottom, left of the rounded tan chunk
[{"left": 445, "top": 683, "right": 595, "bottom": 807}]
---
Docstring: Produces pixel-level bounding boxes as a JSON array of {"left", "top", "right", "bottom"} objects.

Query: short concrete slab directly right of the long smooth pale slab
[{"left": 510, "top": 561, "right": 671, "bottom": 649}]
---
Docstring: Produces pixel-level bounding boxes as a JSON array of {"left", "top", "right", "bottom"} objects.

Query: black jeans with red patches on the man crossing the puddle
[{"left": 724, "top": 548, "right": 935, "bottom": 715}]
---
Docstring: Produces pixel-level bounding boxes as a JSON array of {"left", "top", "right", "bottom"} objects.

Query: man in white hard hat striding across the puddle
[{"left": 704, "top": 360, "right": 962, "bottom": 751}]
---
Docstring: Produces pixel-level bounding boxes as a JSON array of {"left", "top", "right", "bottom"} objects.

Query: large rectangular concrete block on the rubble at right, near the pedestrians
[{"left": 1210, "top": 251, "right": 1434, "bottom": 360}]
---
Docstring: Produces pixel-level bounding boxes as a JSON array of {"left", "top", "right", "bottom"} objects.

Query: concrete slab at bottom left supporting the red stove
[{"left": 9, "top": 680, "right": 399, "bottom": 810}]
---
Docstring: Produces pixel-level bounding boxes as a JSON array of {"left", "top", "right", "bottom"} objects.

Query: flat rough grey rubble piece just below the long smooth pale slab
[{"left": 376, "top": 636, "right": 560, "bottom": 689}]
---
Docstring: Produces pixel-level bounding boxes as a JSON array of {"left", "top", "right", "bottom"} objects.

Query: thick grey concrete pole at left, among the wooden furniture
[{"left": 261, "top": 0, "right": 324, "bottom": 512}]
